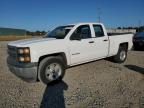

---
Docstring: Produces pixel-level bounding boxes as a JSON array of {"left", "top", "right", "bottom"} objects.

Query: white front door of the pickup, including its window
[{"left": 69, "top": 25, "right": 95, "bottom": 65}]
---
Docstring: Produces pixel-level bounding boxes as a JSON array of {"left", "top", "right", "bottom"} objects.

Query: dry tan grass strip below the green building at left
[{"left": 0, "top": 36, "right": 32, "bottom": 41}]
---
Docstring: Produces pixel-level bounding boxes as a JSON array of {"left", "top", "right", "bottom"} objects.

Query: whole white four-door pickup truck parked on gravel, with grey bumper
[{"left": 7, "top": 23, "right": 133, "bottom": 84}]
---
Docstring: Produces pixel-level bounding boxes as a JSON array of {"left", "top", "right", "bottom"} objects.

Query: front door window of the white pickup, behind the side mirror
[{"left": 72, "top": 25, "right": 91, "bottom": 39}]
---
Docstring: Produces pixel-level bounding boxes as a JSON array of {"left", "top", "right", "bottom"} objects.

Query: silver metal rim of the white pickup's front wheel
[{"left": 45, "top": 63, "right": 62, "bottom": 81}]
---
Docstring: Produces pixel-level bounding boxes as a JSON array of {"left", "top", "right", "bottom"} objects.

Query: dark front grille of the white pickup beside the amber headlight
[{"left": 7, "top": 45, "right": 17, "bottom": 60}]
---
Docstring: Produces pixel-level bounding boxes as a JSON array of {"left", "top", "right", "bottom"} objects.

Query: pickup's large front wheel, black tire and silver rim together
[{"left": 38, "top": 56, "right": 65, "bottom": 84}]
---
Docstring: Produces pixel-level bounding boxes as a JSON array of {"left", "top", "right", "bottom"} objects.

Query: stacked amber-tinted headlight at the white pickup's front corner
[{"left": 17, "top": 47, "right": 31, "bottom": 62}]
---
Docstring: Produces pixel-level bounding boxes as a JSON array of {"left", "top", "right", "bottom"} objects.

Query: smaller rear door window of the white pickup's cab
[{"left": 93, "top": 25, "right": 104, "bottom": 37}]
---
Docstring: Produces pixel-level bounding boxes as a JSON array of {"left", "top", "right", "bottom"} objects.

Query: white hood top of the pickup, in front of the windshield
[{"left": 8, "top": 38, "right": 55, "bottom": 46}]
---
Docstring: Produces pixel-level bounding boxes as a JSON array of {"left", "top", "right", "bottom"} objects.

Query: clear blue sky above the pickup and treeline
[{"left": 0, "top": 0, "right": 144, "bottom": 31}]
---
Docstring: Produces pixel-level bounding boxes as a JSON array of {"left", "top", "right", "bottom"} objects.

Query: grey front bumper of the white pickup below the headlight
[{"left": 7, "top": 57, "right": 37, "bottom": 82}]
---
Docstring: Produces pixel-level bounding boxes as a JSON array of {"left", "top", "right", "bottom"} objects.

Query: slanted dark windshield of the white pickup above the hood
[{"left": 45, "top": 25, "right": 73, "bottom": 39}]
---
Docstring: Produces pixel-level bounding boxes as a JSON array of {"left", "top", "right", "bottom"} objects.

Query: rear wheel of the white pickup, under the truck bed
[{"left": 113, "top": 45, "right": 127, "bottom": 63}]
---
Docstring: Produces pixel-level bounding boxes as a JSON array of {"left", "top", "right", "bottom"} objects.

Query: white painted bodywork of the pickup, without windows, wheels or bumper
[{"left": 8, "top": 23, "right": 133, "bottom": 66}]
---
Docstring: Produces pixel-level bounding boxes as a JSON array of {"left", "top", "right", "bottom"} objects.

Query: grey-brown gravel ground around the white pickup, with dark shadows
[{"left": 0, "top": 42, "right": 144, "bottom": 108}]
